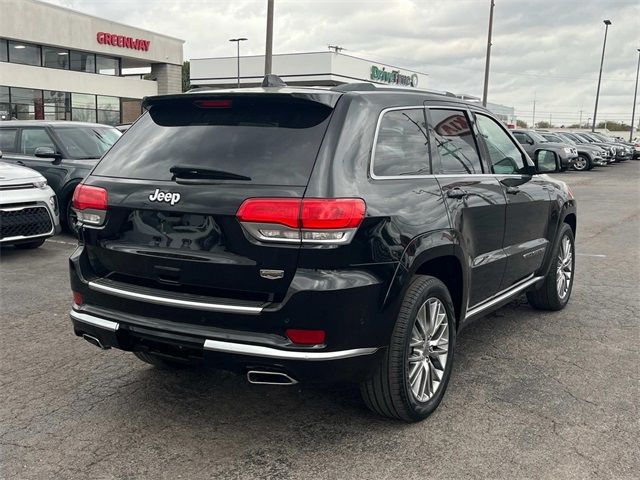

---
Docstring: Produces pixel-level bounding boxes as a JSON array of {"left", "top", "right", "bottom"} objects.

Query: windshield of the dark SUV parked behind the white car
[{"left": 55, "top": 126, "right": 122, "bottom": 160}]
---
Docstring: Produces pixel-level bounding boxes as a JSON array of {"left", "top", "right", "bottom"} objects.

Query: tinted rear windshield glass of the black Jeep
[{"left": 93, "top": 97, "right": 332, "bottom": 185}]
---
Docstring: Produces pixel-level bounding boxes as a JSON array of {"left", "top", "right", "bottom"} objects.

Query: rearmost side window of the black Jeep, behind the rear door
[{"left": 373, "top": 108, "right": 431, "bottom": 176}]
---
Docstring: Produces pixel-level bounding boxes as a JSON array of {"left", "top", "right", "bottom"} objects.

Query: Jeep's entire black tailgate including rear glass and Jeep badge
[{"left": 79, "top": 93, "right": 332, "bottom": 302}]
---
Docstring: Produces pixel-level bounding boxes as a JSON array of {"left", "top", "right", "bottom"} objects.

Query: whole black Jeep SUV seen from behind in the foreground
[{"left": 70, "top": 80, "right": 576, "bottom": 421}]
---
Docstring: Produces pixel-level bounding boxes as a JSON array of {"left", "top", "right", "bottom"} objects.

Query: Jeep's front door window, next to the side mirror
[{"left": 476, "top": 115, "right": 526, "bottom": 175}]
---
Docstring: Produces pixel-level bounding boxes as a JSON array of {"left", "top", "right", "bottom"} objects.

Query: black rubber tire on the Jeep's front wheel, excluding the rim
[{"left": 527, "top": 223, "right": 576, "bottom": 311}]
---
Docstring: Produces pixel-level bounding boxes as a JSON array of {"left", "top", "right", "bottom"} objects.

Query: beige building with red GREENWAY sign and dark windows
[{"left": 0, "top": 0, "right": 184, "bottom": 125}]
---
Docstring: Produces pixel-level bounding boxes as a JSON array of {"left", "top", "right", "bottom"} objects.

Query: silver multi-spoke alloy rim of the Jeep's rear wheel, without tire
[{"left": 407, "top": 297, "right": 449, "bottom": 402}]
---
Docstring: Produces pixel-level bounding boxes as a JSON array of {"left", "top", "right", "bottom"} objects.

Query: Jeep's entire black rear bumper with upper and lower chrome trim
[{"left": 70, "top": 246, "right": 394, "bottom": 382}]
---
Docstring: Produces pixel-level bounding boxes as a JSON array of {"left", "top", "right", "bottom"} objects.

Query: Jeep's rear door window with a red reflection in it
[{"left": 429, "top": 109, "right": 482, "bottom": 174}]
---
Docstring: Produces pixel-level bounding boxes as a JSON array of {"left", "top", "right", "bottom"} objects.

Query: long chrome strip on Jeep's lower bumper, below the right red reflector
[{"left": 204, "top": 339, "right": 378, "bottom": 362}]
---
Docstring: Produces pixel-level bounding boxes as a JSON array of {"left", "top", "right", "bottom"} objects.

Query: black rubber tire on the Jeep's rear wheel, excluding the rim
[{"left": 360, "top": 276, "right": 456, "bottom": 422}]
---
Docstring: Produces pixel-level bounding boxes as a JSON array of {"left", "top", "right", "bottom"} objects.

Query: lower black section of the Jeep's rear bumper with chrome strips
[{"left": 69, "top": 305, "right": 384, "bottom": 382}]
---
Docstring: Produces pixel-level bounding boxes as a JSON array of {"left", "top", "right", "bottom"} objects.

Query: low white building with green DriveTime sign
[{"left": 190, "top": 51, "right": 428, "bottom": 89}]
